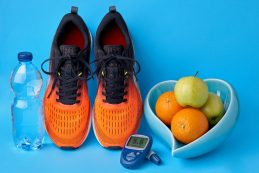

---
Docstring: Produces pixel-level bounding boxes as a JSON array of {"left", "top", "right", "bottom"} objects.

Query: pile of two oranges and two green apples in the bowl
[{"left": 156, "top": 73, "right": 229, "bottom": 144}]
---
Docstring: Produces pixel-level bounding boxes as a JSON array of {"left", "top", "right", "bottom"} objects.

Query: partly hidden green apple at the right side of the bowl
[{"left": 201, "top": 93, "right": 225, "bottom": 126}]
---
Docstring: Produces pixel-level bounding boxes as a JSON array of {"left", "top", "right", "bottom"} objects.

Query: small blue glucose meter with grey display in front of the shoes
[{"left": 120, "top": 134, "right": 161, "bottom": 169}]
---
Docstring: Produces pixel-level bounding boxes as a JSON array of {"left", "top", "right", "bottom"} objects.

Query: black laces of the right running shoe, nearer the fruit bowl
[{"left": 92, "top": 55, "right": 140, "bottom": 104}]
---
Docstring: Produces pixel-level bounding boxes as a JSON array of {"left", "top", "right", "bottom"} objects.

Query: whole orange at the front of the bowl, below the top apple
[{"left": 171, "top": 108, "right": 209, "bottom": 144}]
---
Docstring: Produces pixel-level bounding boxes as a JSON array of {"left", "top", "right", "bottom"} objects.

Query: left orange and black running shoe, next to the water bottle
[{"left": 41, "top": 7, "right": 91, "bottom": 148}]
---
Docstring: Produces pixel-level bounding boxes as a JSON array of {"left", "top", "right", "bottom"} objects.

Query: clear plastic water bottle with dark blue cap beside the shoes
[{"left": 11, "top": 52, "right": 44, "bottom": 150}]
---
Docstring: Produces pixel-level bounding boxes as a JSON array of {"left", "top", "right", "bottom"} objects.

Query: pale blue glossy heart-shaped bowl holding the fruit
[{"left": 144, "top": 79, "right": 239, "bottom": 158}]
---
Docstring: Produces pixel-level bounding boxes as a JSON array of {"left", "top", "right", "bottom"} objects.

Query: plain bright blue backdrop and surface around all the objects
[{"left": 0, "top": 0, "right": 259, "bottom": 173}]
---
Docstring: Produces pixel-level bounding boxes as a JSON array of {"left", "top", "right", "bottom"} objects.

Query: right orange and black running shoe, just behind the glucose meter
[{"left": 93, "top": 7, "right": 142, "bottom": 148}]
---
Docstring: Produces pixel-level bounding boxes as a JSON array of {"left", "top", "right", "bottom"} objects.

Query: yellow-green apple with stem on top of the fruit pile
[{"left": 174, "top": 76, "right": 209, "bottom": 108}]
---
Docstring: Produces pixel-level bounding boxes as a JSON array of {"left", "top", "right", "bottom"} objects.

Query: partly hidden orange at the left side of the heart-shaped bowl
[{"left": 156, "top": 91, "right": 183, "bottom": 126}]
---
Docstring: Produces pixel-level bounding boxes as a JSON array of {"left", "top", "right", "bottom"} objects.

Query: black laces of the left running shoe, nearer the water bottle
[{"left": 41, "top": 51, "right": 93, "bottom": 105}]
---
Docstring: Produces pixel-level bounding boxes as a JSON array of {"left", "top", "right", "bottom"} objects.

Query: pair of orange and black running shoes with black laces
[{"left": 41, "top": 6, "right": 142, "bottom": 148}]
